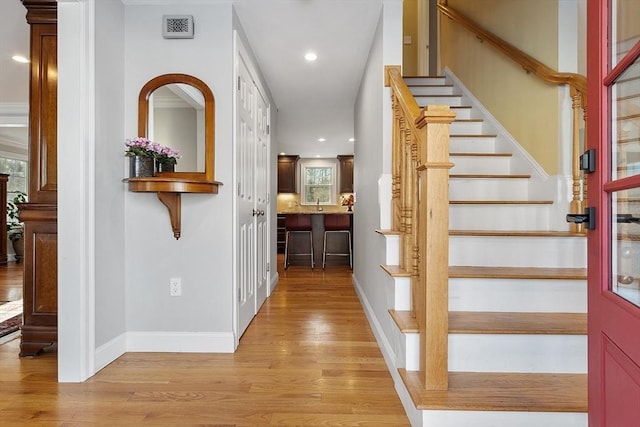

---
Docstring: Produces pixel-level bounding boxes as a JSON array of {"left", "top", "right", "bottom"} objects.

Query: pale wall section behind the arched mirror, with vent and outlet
[{"left": 122, "top": 3, "right": 233, "bottom": 351}]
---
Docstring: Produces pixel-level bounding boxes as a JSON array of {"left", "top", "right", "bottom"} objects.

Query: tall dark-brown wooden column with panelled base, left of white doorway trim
[{"left": 19, "top": 0, "right": 58, "bottom": 356}]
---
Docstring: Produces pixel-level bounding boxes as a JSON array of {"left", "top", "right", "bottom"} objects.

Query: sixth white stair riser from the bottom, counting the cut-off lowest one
[{"left": 449, "top": 178, "right": 529, "bottom": 201}]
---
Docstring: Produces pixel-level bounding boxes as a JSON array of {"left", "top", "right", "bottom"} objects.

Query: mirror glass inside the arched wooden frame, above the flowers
[{"left": 148, "top": 83, "right": 204, "bottom": 172}]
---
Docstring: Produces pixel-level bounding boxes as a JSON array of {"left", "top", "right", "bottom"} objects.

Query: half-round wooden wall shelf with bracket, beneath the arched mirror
[{"left": 123, "top": 176, "right": 222, "bottom": 240}]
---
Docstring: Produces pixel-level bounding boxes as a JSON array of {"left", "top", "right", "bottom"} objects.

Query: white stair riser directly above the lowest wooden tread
[{"left": 449, "top": 334, "right": 587, "bottom": 374}]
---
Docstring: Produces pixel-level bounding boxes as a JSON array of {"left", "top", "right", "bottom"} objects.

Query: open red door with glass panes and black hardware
[{"left": 587, "top": 0, "right": 640, "bottom": 427}]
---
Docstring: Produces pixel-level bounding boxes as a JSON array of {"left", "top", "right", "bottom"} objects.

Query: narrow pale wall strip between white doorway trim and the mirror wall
[{"left": 95, "top": 1, "right": 126, "bottom": 354}]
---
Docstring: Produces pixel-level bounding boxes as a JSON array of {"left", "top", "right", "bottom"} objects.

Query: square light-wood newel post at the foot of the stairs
[{"left": 415, "top": 105, "right": 455, "bottom": 390}]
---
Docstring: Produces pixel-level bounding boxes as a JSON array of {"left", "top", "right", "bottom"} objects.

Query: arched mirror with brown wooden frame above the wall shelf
[{"left": 138, "top": 74, "right": 215, "bottom": 182}]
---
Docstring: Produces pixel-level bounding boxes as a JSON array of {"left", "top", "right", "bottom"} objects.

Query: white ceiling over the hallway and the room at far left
[{"left": 0, "top": 0, "right": 382, "bottom": 157}]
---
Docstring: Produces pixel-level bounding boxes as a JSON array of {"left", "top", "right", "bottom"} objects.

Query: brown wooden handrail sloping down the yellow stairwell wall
[{"left": 438, "top": 2, "right": 587, "bottom": 108}]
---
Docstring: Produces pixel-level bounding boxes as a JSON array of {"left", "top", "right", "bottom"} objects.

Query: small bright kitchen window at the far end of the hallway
[{"left": 300, "top": 160, "right": 336, "bottom": 205}]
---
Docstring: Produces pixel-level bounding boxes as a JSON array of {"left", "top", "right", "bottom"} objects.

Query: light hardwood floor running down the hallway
[{"left": 0, "top": 258, "right": 409, "bottom": 427}]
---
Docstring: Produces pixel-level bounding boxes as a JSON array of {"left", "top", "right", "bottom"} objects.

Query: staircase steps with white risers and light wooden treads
[{"left": 379, "top": 77, "right": 587, "bottom": 427}]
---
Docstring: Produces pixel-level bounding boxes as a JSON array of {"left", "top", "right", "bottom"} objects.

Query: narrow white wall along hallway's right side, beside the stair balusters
[{"left": 353, "top": 1, "right": 402, "bottom": 378}]
